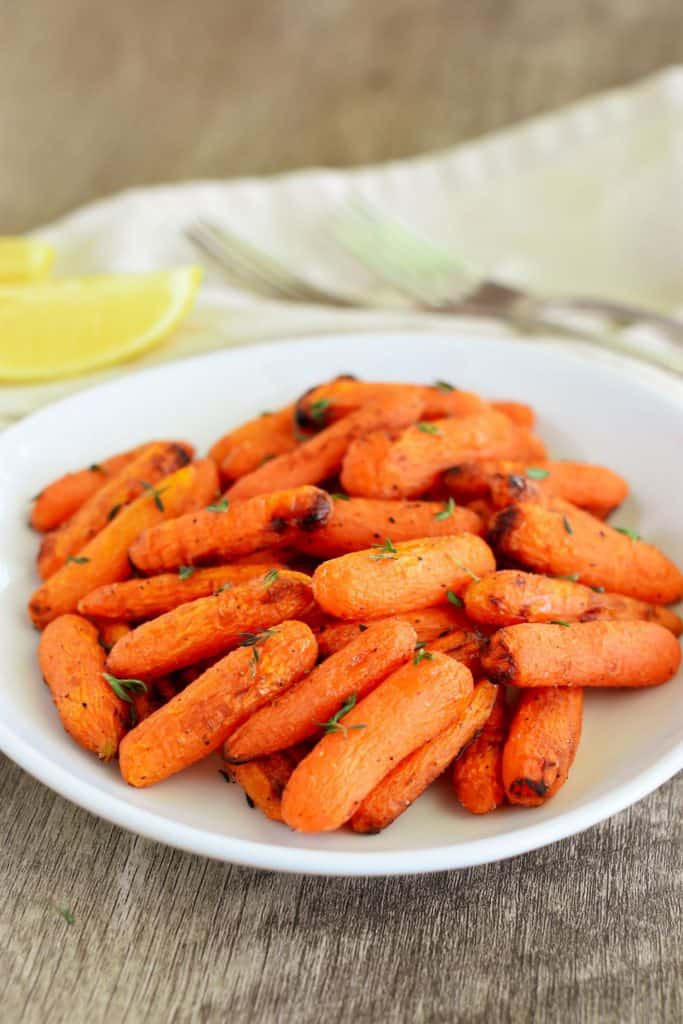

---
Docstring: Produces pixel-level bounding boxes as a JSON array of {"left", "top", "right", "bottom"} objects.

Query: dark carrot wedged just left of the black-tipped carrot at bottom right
[{"left": 453, "top": 686, "right": 508, "bottom": 814}]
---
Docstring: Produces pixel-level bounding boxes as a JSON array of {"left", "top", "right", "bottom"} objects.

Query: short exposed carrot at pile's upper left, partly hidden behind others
[{"left": 209, "top": 406, "right": 299, "bottom": 481}]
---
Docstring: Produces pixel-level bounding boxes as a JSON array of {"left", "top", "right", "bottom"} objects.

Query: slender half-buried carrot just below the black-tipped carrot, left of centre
[{"left": 78, "top": 562, "right": 284, "bottom": 622}]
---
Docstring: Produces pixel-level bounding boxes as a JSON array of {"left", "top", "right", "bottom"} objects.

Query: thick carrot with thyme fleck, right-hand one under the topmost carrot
[{"left": 341, "top": 409, "right": 541, "bottom": 498}]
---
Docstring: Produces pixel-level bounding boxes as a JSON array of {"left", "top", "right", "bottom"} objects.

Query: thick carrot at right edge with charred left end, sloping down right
[{"left": 489, "top": 499, "right": 683, "bottom": 604}]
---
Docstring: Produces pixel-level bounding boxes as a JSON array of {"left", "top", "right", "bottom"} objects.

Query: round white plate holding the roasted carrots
[{"left": 0, "top": 332, "right": 683, "bottom": 874}]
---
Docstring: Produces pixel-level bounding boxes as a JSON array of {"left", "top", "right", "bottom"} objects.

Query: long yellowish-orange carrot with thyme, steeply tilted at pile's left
[{"left": 29, "top": 459, "right": 216, "bottom": 629}]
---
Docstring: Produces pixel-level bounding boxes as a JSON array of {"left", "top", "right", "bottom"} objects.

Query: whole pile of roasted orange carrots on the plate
[{"left": 29, "top": 377, "right": 683, "bottom": 833}]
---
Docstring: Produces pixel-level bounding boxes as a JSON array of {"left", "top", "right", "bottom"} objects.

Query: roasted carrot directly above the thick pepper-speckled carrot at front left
[{"left": 106, "top": 571, "right": 312, "bottom": 679}]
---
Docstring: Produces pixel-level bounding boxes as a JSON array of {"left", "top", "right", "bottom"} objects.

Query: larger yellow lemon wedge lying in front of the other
[{"left": 0, "top": 266, "right": 202, "bottom": 382}]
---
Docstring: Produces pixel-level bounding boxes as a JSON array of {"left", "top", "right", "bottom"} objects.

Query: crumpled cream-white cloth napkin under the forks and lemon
[{"left": 0, "top": 69, "right": 683, "bottom": 425}]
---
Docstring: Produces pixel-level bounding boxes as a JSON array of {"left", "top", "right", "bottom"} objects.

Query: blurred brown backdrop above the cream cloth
[{"left": 0, "top": 0, "right": 683, "bottom": 233}]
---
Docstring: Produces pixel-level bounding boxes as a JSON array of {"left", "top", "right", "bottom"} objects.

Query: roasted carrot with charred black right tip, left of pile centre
[{"left": 130, "top": 485, "right": 333, "bottom": 572}]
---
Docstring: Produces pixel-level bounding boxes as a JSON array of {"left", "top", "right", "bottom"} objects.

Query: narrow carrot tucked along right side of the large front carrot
[{"left": 351, "top": 679, "right": 496, "bottom": 833}]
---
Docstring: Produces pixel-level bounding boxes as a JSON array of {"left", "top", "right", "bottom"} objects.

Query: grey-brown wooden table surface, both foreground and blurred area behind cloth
[{"left": 0, "top": 0, "right": 683, "bottom": 1024}]
